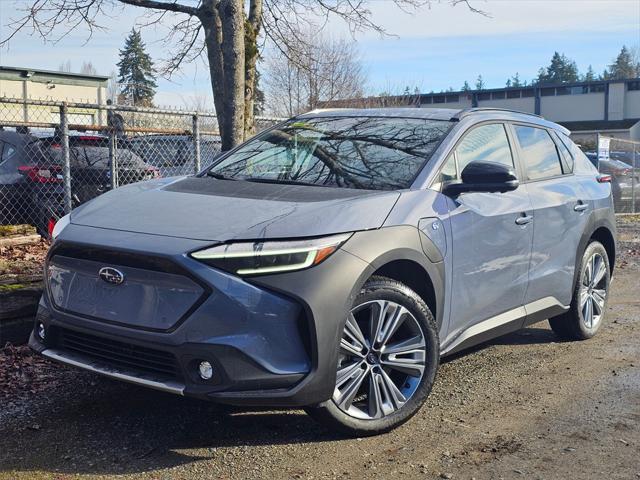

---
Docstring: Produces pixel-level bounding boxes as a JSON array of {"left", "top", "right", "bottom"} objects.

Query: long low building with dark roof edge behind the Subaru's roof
[{"left": 323, "top": 78, "right": 640, "bottom": 141}]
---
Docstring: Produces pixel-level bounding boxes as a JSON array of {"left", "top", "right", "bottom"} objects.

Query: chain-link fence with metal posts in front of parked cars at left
[{"left": 0, "top": 98, "right": 281, "bottom": 237}]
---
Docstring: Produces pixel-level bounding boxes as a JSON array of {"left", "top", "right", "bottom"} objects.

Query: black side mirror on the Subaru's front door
[{"left": 443, "top": 162, "right": 520, "bottom": 196}]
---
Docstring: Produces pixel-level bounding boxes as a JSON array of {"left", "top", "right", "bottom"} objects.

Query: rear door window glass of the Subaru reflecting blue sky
[{"left": 514, "top": 125, "right": 562, "bottom": 180}]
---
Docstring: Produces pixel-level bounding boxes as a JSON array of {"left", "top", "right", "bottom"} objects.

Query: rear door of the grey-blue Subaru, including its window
[{"left": 511, "top": 124, "right": 592, "bottom": 308}]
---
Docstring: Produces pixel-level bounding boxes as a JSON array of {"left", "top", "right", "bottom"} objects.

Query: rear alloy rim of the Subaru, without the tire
[{"left": 580, "top": 253, "right": 608, "bottom": 329}]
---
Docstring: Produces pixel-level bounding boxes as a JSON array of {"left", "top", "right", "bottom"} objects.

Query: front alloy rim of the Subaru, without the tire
[{"left": 333, "top": 300, "right": 427, "bottom": 420}]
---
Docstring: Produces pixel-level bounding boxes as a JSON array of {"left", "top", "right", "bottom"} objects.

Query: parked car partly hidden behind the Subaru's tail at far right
[{"left": 585, "top": 152, "right": 640, "bottom": 212}]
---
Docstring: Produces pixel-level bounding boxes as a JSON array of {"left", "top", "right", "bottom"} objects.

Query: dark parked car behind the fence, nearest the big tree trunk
[{"left": 129, "top": 135, "right": 221, "bottom": 177}]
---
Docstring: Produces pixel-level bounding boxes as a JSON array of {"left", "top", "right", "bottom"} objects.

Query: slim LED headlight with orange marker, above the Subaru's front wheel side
[{"left": 191, "top": 233, "right": 351, "bottom": 275}]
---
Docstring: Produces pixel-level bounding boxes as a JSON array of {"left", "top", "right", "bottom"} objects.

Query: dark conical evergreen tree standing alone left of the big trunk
[{"left": 117, "top": 29, "right": 157, "bottom": 106}]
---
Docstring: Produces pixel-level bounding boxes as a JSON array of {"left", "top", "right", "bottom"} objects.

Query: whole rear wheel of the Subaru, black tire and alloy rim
[{"left": 549, "top": 241, "right": 611, "bottom": 340}]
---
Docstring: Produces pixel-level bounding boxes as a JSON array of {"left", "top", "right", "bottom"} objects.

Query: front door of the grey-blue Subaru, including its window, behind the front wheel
[{"left": 433, "top": 122, "right": 533, "bottom": 349}]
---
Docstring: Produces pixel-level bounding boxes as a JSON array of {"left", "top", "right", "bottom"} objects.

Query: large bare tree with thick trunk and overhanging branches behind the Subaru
[{"left": 0, "top": 0, "right": 482, "bottom": 150}]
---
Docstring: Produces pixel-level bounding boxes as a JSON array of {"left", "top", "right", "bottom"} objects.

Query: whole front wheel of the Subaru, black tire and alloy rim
[{"left": 306, "top": 277, "right": 440, "bottom": 436}]
